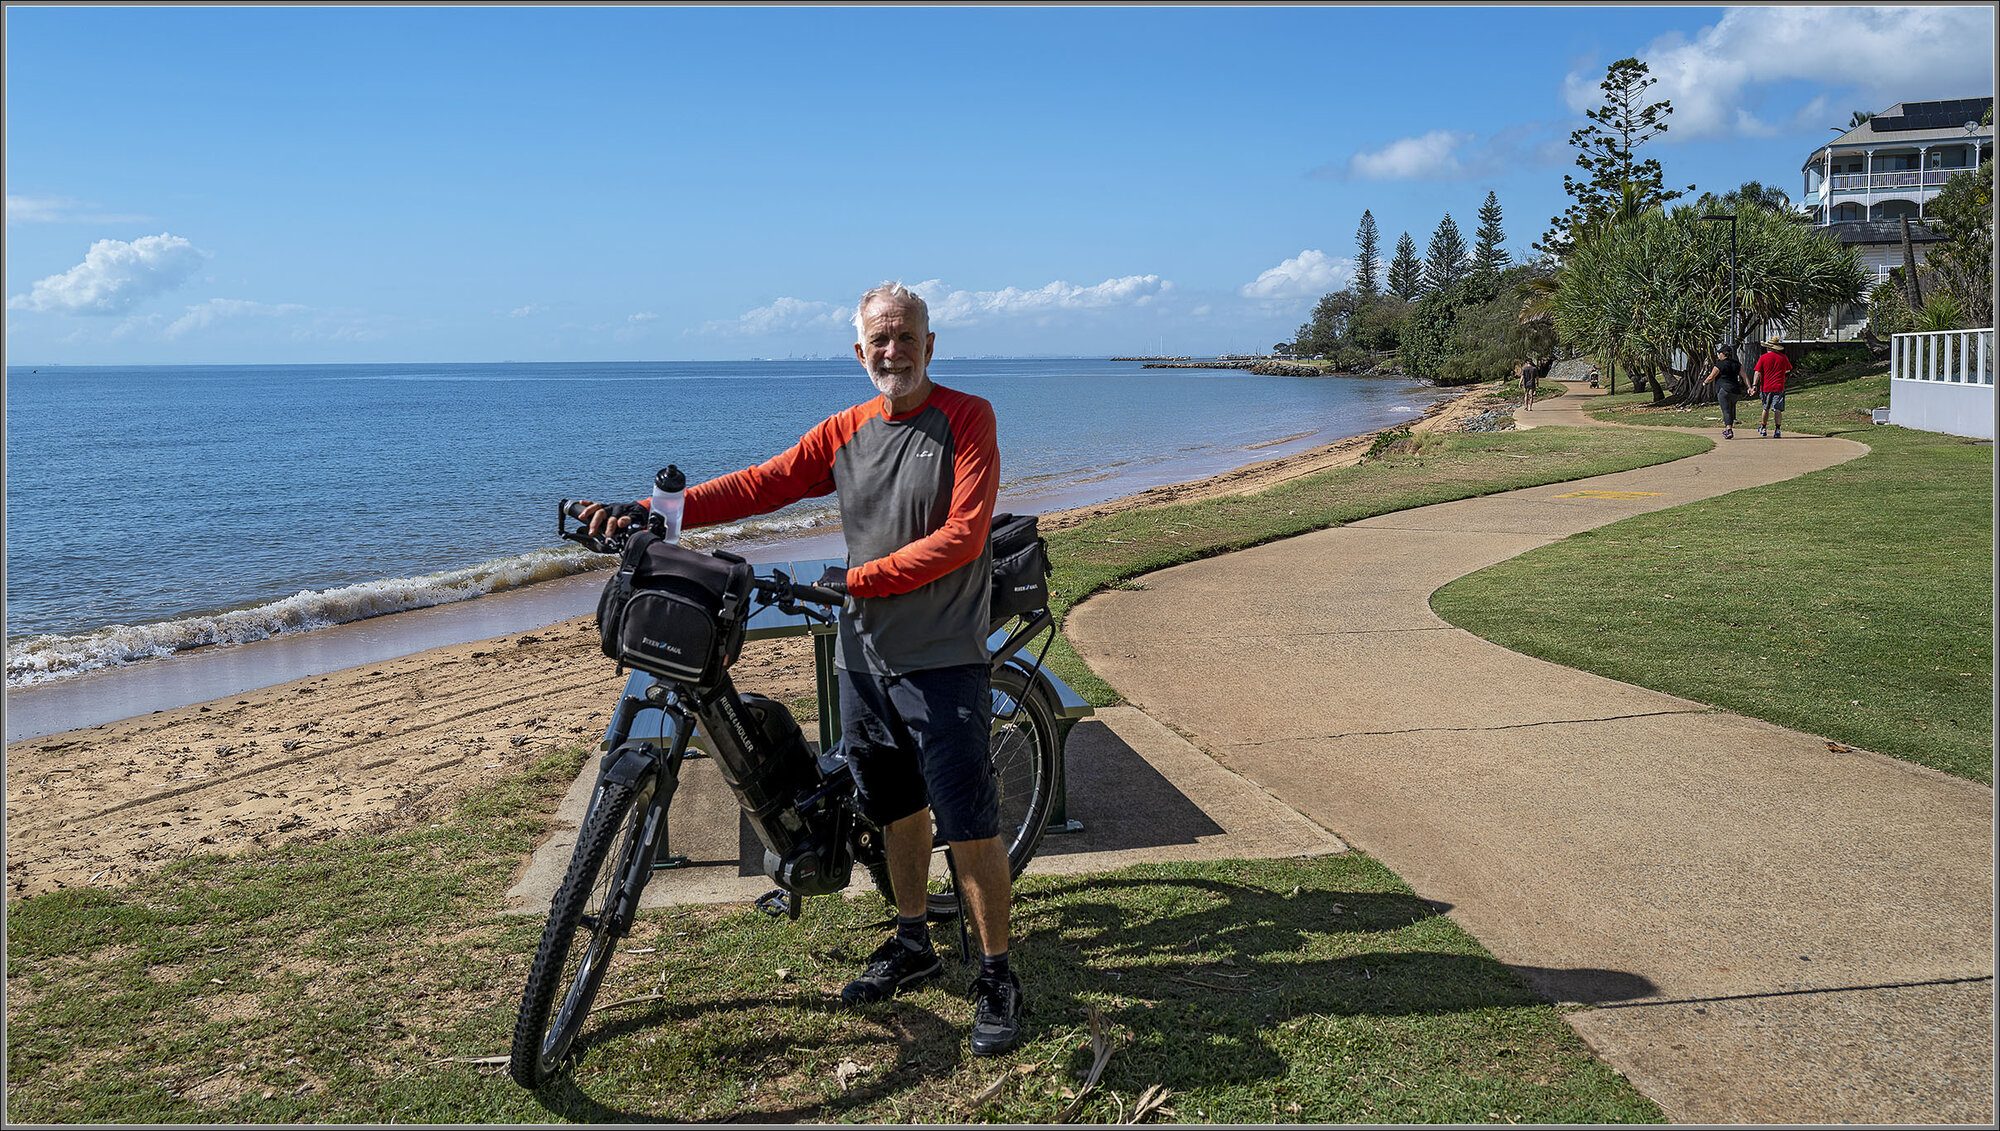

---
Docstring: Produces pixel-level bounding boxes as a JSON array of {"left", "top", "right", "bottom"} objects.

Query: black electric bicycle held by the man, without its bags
[{"left": 508, "top": 500, "right": 1062, "bottom": 1089}]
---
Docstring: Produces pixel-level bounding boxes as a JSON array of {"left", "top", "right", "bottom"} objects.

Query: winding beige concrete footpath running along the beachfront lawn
[{"left": 1068, "top": 386, "right": 1994, "bottom": 1125}]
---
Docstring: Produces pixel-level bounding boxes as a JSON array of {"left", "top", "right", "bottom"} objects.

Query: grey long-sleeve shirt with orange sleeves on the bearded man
[{"left": 668, "top": 386, "right": 1000, "bottom": 675}]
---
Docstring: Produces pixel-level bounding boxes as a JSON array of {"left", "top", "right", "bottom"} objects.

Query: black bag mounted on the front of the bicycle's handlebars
[{"left": 598, "top": 532, "right": 750, "bottom": 687}]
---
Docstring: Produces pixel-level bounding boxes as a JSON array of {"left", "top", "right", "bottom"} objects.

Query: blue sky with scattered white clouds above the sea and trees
[{"left": 6, "top": 6, "right": 1994, "bottom": 366}]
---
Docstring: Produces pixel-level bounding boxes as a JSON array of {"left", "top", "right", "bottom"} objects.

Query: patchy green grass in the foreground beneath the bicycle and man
[{"left": 6, "top": 749, "right": 1660, "bottom": 1123}]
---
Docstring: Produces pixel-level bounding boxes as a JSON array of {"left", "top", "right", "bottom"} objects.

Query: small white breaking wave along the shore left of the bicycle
[{"left": 6, "top": 546, "right": 610, "bottom": 687}]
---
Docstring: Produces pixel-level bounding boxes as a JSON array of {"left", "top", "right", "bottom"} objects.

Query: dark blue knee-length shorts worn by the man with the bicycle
[{"left": 840, "top": 663, "right": 1000, "bottom": 843}]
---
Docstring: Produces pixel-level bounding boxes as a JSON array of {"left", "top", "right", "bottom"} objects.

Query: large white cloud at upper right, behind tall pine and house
[{"left": 1564, "top": 6, "right": 1994, "bottom": 140}]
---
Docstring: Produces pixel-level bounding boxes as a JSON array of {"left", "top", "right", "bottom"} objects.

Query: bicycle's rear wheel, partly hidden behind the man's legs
[{"left": 930, "top": 667, "right": 1062, "bottom": 917}]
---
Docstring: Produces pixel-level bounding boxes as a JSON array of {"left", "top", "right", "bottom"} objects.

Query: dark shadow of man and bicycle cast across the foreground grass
[{"left": 516, "top": 875, "right": 1654, "bottom": 1123}]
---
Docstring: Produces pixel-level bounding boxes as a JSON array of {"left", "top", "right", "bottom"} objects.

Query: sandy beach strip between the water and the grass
[{"left": 6, "top": 392, "right": 1486, "bottom": 899}]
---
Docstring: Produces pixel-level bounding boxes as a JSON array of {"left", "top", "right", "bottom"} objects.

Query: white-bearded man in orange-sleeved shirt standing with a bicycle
[{"left": 584, "top": 284, "right": 1022, "bottom": 1055}]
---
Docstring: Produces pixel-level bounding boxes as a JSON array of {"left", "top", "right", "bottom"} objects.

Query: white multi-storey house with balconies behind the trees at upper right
[{"left": 1800, "top": 98, "right": 1994, "bottom": 291}]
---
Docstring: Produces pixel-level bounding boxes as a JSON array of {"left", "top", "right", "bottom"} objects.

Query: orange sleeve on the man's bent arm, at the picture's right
[{"left": 848, "top": 392, "right": 1000, "bottom": 597}]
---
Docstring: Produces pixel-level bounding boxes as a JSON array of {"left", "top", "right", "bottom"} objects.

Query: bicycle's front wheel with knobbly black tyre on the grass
[{"left": 508, "top": 779, "right": 658, "bottom": 1087}]
